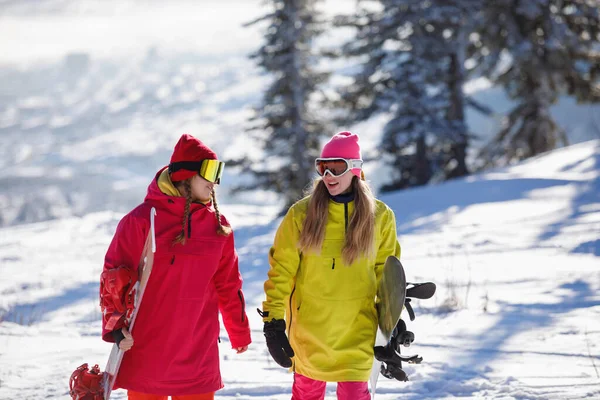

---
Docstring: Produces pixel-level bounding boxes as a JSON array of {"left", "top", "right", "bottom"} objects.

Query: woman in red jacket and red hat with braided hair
[{"left": 100, "top": 134, "right": 251, "bottom": 400}]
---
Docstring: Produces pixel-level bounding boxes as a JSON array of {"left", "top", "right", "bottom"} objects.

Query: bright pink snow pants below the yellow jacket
[{"left": 292, "top": 374, "right": 371, "bottom": 400}]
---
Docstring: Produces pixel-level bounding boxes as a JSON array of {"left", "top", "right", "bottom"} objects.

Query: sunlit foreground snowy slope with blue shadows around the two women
[{"left": 0, "top": 141, "right": 600, "bottom": 400}]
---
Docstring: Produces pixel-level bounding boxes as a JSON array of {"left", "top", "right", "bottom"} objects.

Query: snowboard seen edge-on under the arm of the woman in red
[{"left": 102, "top": 207, "right": 156, "bottom": 400}]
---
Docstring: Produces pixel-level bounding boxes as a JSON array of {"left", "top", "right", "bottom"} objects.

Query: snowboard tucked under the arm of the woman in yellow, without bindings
[{"left": 369, "top": 256, "right": 406, "bottom": 399}]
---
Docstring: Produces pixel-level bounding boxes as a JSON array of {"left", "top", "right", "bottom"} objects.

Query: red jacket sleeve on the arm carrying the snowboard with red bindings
[{"left": 100, "top": 210, "right": 149, "bottom": 342}]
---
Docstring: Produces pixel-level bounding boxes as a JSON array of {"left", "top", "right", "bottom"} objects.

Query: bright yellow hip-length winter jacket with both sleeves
[{"left": 263, "top": 197, "right": 400, "bottom": 382}]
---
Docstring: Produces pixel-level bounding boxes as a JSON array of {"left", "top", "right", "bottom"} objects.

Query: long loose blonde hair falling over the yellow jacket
[{"left": 298, "top": 176, "right": 375, "bottom": 265}]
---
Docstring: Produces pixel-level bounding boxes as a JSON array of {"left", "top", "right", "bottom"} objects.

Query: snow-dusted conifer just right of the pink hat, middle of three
[{"left": 334, "top": 0, "right": 479, "bottom": 190}]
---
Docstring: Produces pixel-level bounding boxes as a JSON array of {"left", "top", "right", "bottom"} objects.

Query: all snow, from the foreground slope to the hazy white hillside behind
[{"left": 0, "top": 0, "right": 600, "bottom": 400}]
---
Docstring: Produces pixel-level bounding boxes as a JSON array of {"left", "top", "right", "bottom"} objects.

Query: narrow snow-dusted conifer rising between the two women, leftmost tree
[{"left": 234, "top": 0, "right": 328, "bottom": 211}]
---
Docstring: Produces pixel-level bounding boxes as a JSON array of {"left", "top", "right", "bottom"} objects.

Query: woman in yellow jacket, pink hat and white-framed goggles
[{"left": 261, "top": 132, "right": 400, "bottom": 400}]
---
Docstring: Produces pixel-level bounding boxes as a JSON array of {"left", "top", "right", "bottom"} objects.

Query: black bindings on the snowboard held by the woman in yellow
[{"left": 374, "top": 282, "right": 436, "bottom": 382}]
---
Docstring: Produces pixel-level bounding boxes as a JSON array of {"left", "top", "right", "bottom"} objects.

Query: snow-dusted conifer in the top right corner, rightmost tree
[{"left": 473, "top": 0, "right": 600, "bottom": 165}]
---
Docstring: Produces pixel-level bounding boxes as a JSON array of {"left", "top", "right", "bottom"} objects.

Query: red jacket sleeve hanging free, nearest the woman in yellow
[{"left": 213, "top": 233, "right": 252, "bottom": 348}]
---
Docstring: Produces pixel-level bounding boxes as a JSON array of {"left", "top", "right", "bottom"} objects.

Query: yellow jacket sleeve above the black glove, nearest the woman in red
[{"left": 263, "top": 207, "right": 300, "bottom": 321}]
